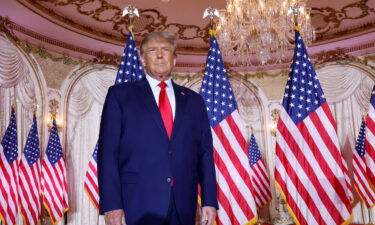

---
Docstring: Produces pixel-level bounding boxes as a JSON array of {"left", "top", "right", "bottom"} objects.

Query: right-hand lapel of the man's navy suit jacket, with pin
[{"left": 171, "top": 81, "right": 187, "bottom": 140}]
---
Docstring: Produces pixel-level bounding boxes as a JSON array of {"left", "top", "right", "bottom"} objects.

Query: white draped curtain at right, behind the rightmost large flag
[{"left": 317, "top": 65, "right": 375, "bottom": 224}]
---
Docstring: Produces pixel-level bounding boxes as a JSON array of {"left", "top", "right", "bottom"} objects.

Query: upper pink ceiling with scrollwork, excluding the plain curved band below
[{"left": 17, "top": 0, "right": 375, "bottom": 47}]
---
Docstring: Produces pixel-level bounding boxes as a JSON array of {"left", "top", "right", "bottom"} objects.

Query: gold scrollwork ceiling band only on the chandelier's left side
[{"left": 17, "top": 0, "right": 209, "bottom": 44}]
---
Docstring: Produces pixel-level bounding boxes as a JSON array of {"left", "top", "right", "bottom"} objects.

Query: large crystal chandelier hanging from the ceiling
[{"left": 216, "top": 0, "right": 315, "bottom": 66}]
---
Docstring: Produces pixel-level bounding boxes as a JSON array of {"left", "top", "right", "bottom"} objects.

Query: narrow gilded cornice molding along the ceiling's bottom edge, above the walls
[{"left": 0, "top": 16, "right": 375, "bottom": 71}]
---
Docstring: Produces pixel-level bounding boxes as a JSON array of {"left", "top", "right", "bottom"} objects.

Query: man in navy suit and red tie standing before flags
[{"left": 98, "top": 32, "right": 218, "bottom": 225}]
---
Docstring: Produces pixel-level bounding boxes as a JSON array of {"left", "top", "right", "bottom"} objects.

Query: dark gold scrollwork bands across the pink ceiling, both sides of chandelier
[{"left": 17, "top": 0, "right": 375, "bottom": 44}]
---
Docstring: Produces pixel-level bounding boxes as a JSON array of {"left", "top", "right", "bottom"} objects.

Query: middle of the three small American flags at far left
[{"left": 19, "top": 115, "right": 41, "bottom": 225}]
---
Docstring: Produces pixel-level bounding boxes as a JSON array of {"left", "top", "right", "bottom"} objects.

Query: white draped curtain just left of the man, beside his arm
[{"left": 66, "top": 70, "right": 116, "bottom": 225}]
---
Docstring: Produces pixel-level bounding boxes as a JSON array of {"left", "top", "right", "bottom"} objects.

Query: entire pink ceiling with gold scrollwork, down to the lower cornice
[{"left": 0, "top": 0, "right": 375, "bottom": 67}]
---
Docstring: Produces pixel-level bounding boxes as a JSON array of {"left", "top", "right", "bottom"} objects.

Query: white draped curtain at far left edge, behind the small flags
[{"left": 0, "top": 33, "right": 44, "bottom": 225}]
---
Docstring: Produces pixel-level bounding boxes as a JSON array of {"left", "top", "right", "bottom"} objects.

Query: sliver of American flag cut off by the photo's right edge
[{"left": 366, "top": 85, "right": 375, "bottom": 190}]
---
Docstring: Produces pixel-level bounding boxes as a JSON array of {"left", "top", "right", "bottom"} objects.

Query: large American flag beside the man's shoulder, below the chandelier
[{"left": 200, "top": 31, "right": 257, "bottom": 225}]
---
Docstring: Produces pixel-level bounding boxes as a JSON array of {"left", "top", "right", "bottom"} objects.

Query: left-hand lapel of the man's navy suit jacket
[{"left": 137, "top": 78, "right": 168, "bottom": 138}]
